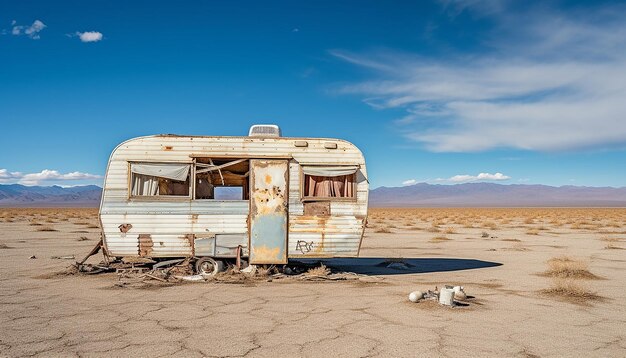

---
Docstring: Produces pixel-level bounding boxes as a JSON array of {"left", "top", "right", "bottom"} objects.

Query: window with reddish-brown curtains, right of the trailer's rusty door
[{"left": 302, "top": 166, "right": 358, "bottom": 199}]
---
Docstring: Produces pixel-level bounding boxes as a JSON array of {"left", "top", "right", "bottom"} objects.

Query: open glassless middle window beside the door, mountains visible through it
[{"left": 194, "top": 158, "right": 250, "bottom": 200}]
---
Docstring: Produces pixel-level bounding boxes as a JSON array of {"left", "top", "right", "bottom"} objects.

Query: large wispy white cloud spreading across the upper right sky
[{"left": 331, "top": 1, "right": 626, "bottom": 152}]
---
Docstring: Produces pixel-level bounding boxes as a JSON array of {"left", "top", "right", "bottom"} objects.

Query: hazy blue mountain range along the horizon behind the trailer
[{"left": 0, "top": 183, "right": 626, "bottom": 207}]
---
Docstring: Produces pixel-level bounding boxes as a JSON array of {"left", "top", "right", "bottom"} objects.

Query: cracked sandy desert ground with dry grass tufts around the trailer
[{"left": 0, "top": 208, "right": 626, "bottom": 357}]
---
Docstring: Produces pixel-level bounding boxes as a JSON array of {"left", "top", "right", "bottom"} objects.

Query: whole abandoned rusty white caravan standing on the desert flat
[{"left": 99, "top": 125, "right": 368, "bottom": 274}]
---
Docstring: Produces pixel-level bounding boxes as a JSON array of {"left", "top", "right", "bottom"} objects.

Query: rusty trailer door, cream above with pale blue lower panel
[{"left": 248, "top": 159, "right": 289, "bottom": 264}]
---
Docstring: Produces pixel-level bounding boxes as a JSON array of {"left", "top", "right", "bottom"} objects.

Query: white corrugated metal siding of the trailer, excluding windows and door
[{"left": 100, "top": 136, "right": 368, "bottom": 257}]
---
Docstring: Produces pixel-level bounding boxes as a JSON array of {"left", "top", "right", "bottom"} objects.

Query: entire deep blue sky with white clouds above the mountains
[{"left": 0, "top": 1, "right": 626, "bottom": 187}]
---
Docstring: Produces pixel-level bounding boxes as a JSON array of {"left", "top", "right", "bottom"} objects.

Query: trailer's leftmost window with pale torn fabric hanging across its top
[{"left": 130, "top": 163, "right": 190, "bottom": 197}]
